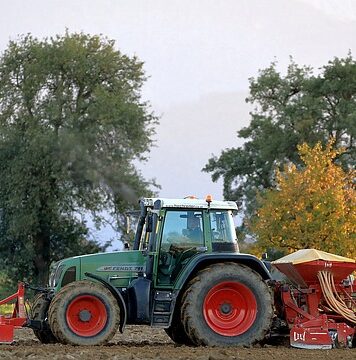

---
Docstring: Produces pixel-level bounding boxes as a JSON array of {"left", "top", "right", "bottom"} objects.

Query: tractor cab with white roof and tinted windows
[{"left": 133, "top": 196, "right": 238, "bottom": 287}]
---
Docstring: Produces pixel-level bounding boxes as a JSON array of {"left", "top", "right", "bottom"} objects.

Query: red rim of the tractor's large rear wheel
[{"left": 203, "top": 281, "right": 257, "bottom": 336}]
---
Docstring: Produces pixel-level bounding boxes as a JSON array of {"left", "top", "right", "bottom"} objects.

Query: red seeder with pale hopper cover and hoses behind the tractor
[{"left": 273, "top": 250, "right": 356, "bottom": 349}]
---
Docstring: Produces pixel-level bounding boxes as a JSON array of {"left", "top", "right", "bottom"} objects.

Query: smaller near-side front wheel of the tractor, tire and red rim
[{"left": 48, "top": 280, "right": 120, "bottom": 345}]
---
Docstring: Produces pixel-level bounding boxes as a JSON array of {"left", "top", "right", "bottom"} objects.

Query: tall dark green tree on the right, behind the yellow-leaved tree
[{"left": 203, "top": 55, "right": 356, "bottom": 222}]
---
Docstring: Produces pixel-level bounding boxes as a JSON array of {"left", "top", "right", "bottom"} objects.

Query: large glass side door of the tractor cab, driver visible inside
[{"left": 157, "top": 210, "right": 205, "bottom": 285}]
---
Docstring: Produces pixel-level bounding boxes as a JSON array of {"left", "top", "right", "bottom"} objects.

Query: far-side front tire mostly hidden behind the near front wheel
[{"left": 31, "top": 293, "right": 58, "bottom": 344}]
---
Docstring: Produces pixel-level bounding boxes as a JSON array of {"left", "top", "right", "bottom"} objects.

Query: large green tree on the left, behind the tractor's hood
[{"left": 0, "top": 33, "right": 157, "bottom": 284}]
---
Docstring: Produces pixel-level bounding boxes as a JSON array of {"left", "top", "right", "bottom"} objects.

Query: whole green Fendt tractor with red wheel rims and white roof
[{"left": 31, "top": 196, "right": 273, "bottom": 346}]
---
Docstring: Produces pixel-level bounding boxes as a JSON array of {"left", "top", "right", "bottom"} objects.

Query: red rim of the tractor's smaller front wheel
[{"left": 66, "top": 295, "right": 108, "bottom": 337}]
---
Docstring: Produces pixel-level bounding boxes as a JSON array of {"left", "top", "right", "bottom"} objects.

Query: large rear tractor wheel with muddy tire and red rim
[{"left": 182, "top": 263, "right": 273, "bottom": 346}]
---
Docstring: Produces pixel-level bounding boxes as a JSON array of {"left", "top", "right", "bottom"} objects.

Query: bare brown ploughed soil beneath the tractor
[{"left": 0, "top": 326, "right": 356, "bottom": 360}]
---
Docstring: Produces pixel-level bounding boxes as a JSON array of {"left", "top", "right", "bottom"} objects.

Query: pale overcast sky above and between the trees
[{"left": 0, "top": 0, "right": 356, "bottom": 242}]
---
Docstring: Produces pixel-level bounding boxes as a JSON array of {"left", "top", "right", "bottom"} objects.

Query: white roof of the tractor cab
[{"left": 142, "top": 198, "right": 238, "bottom": 210}]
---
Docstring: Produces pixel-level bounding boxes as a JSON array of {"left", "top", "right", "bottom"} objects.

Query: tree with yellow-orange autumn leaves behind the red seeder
[{"left": 251, "top": 141, "right": 356, "bottom": 258}]
